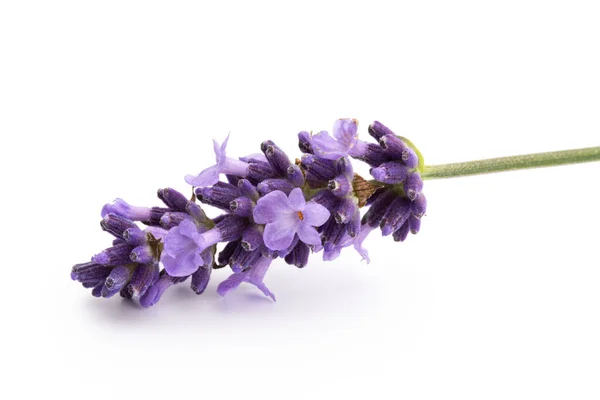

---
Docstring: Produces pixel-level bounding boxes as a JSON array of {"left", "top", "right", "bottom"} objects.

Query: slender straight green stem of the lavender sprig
[{"left": 421, "top": 147, "right": 600, "bottom": 179}]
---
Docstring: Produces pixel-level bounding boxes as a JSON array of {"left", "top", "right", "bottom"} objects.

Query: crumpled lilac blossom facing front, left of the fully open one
[{"left": 161, "top": 219, "right": 211, "bottom": 276}]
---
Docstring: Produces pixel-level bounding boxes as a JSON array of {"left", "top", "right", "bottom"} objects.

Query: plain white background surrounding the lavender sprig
[{"left": 0, "top": 0, "right": 600, "bottom": 400}]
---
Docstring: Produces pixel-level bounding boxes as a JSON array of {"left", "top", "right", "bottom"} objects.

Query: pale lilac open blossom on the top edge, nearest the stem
[{"left": 309, "top": 119, "right": 367, "bottom": 160}]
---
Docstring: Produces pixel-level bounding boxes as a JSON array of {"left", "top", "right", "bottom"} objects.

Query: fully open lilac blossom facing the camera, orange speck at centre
[{"left": 253, "top": 188, "right": 330, "bottom": 250}]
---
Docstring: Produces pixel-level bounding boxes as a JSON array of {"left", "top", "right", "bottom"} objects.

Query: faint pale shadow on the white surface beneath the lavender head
[{"left": 85, "top": 264, "right": 380, "bottom": 330}]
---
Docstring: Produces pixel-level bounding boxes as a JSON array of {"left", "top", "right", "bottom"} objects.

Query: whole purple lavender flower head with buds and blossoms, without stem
[{"left": 71, "top": 119, "right": 426, "bottom": 307}]
